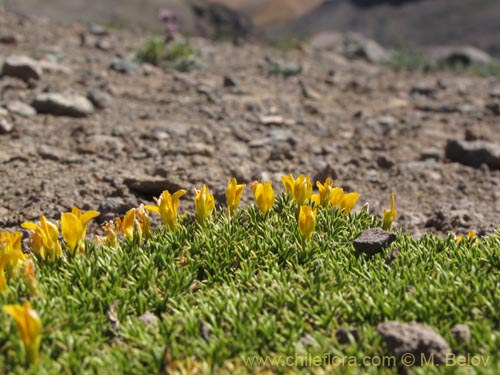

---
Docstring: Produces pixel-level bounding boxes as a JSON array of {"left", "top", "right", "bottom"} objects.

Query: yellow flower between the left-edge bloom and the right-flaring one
[{"left": 21, "top": 215, "right": 62, "bottom": 260}]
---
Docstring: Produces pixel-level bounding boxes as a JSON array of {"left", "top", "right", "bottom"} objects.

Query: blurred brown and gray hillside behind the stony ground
[{"left": 0, "top": 0, "right": 500, "bottom": 56}]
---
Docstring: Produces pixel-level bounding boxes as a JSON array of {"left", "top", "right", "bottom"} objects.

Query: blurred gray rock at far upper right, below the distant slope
[{"left": 429, "top": 46, "right": 493, "bottom": 66}]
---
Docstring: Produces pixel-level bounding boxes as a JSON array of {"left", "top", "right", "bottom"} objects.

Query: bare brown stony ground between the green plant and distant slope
[{"left": 0, "top": 11, "right": 500, "bottom": 232}]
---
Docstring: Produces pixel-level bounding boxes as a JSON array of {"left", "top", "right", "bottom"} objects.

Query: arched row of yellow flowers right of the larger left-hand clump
[{"left": 97, "top": 174, "right": 376, "bottom": 246}]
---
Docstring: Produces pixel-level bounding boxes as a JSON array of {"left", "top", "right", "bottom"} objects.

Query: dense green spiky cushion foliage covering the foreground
[{"left": 0, "top": 195, "right": 500, "bottom": 375}]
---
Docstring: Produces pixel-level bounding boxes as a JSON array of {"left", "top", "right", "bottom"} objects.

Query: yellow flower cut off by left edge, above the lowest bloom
[{"left": 0, "top": 232, "right": 28, "bottom": 292}]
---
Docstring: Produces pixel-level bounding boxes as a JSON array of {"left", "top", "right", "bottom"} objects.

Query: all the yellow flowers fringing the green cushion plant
[{"left": 0, "top": 175, "right": 396, "bottom": 363}]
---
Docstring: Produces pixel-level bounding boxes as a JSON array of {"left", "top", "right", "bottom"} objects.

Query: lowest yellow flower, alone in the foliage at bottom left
[{"left": 3, "top": 301, "right": 42, "bottom": 363}]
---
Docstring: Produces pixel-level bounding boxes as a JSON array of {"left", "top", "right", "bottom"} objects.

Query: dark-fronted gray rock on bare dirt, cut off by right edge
[{"left": 445, "top": 139, "right": 500, "bottom": 169}]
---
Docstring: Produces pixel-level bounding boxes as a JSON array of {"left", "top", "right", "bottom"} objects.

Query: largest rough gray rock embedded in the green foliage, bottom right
[{"left": 377, "top": 321, "right": 451, "bottom": 366}]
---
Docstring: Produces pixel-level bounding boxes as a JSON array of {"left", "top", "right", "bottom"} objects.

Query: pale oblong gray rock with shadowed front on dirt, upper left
[{"left": 32, "top": 93, "right": 94, "bottom": 117}]
